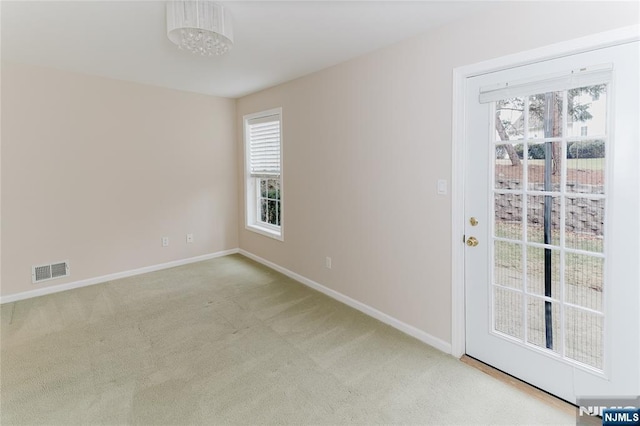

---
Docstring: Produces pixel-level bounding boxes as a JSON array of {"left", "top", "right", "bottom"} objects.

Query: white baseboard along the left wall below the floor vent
[{"left": 0, "top": 248, "right": 239, "bottom": 304}]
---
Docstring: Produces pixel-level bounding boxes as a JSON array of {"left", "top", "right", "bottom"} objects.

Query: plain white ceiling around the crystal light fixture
[{"left": 0, "top": 0, "right": 491, "bottom": 97}]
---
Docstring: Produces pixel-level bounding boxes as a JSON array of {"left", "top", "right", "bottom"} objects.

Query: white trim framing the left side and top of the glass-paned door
[{"left": 451, "top": 25, "right": 640, "bottom": 358}]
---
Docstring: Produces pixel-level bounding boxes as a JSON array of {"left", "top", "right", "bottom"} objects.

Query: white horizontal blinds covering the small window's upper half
[{"left": 247, "top": 115, "right": 280, "bottom": 177}]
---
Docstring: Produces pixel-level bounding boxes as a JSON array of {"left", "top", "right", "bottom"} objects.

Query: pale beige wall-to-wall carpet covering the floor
[{"left": 0, "top": 255, "right": 575, "bottom": 425}]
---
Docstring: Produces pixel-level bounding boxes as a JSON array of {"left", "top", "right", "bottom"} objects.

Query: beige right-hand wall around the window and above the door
[{"left": 237, "top": 2, "right": 638, "bottom": 342}]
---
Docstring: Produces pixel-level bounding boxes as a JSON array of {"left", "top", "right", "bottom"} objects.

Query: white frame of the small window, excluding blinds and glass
[{"left": 243, "top": 108, "right": 284, "bottom": 241}]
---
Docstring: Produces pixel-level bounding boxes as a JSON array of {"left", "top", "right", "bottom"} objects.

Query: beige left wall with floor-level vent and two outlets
[{"left": 1, "top": 63, "right": 238, "bottom": 296}]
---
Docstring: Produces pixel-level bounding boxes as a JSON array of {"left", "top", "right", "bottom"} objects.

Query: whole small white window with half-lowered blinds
[{"left": 244, "top": 108, "right": 283, "bottom": 240}]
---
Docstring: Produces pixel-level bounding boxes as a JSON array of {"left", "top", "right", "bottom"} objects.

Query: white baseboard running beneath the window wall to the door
[{"left": 238, "top": 249, "right": 451, "bottom": 354}]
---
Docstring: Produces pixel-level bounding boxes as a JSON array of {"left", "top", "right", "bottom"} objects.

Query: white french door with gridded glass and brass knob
[{"left": 465, "top": 42, "right": 640, "bottom": 403}]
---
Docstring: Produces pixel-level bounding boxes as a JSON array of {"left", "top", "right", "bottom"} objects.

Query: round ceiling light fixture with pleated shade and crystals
[{"left": 167, "top": 0, "right": 233, "bottom": 56}]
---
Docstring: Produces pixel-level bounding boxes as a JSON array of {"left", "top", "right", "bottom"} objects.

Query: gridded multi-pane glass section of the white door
[{"left": 489, "top": 82, "right": 610, "bottom": 373}]
